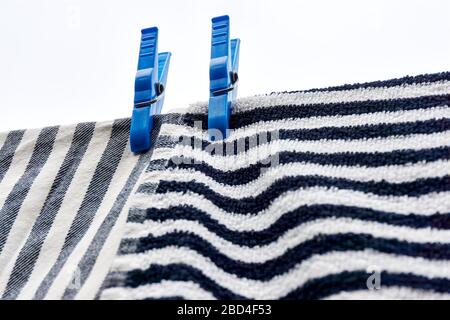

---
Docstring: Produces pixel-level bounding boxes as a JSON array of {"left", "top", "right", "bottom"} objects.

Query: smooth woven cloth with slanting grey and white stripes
[{"left": 0, "top": 119, "right": 155, "bottom": 299}]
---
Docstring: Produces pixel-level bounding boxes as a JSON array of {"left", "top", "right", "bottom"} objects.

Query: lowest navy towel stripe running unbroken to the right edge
[{"left": 119, "top": 232, "right": 450, "bottom": 280}]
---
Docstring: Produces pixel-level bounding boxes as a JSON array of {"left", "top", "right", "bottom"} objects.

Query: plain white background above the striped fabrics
[{"left": 0, "top": 0, "right": 450, "bottom": 131}]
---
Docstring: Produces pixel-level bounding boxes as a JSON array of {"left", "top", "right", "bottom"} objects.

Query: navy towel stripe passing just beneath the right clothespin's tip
[{"left": 179, "top": 118, "right": 450, "bottom": 155}]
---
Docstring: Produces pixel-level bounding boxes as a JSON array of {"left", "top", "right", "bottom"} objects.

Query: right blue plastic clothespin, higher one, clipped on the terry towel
[{"left": 208, "top": 16, "right": 240, "bottom": 139}]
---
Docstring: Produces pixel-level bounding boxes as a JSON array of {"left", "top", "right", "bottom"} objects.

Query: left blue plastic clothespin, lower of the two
[{"left": 130, "top": 27, "right": 171, "bottom": 153}]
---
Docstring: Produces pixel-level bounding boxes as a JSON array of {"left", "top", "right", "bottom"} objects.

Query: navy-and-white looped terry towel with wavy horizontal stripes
[{"left": 99, "top": 73, "right": 450, "bottom": 299}]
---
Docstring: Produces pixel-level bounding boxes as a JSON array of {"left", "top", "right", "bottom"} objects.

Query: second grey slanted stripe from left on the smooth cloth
[{"left": 0, "top": 127, "right": 58, "bottom": 252}]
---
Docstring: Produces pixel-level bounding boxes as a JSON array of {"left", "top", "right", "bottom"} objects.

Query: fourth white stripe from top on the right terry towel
[{"left": 144, "top": 160, "right": 450, "bottom": 199}]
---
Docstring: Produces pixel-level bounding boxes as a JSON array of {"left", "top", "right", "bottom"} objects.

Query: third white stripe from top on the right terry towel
[{"left": 153, "top": 131, "right": 450, "bottom": 171}]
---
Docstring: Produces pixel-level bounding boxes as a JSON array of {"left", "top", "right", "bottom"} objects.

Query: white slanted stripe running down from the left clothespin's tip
[{"left": 45, "top": 144, "right": 139, "bottom": 300}]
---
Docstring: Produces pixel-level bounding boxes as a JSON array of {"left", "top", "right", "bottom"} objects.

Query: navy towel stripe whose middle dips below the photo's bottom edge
[{"left": 114, "top": 264, "right": 450, "bottom": 299}]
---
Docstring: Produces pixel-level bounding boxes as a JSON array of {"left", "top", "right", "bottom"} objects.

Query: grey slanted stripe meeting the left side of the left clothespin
[{"left": 34, "top": 119, "right": 130, "bottom": 299}]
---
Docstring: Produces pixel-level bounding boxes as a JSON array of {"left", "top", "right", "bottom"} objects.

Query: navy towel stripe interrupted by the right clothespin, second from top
[{"left": 183, "top": 95, "right": 450, "bottom": 130}]
